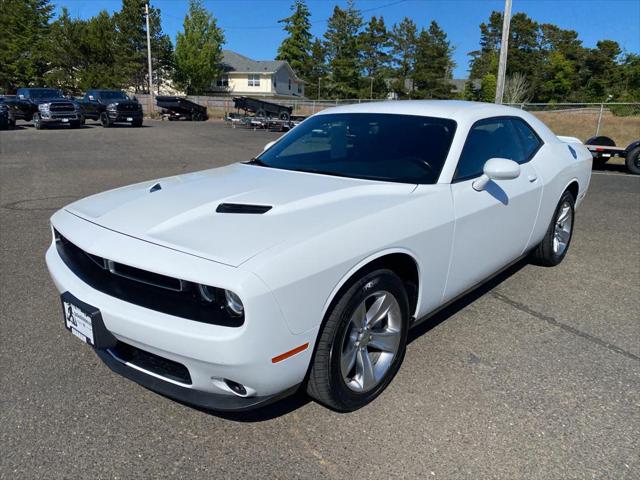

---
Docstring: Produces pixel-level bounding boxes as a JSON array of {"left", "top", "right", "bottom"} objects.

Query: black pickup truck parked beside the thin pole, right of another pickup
[{"left": 80, "top": 89, "right": 143, "bottom": 128}]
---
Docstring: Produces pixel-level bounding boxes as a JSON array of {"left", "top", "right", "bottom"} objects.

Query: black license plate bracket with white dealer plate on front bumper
[{"left": 60, "top": 292, "right": 118, "bottom": 349}]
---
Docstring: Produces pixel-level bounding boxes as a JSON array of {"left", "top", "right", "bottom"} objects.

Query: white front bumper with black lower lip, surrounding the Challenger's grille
[{"left": 46, "top": 211, "right": 317, "bottom": 410}]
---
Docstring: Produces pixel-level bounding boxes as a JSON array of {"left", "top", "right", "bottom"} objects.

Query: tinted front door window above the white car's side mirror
[{"left": 454, "top": 117, "right": 528, "bottom": 181}]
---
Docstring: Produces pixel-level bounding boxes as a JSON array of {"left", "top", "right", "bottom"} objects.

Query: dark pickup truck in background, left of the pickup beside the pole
[{"left": 14, "top": 88, "right": 82, "bottom": 130}]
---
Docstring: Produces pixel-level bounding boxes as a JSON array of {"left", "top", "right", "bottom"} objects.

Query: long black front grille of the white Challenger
[{"left": 54, "top": 231, "right": 244, "bottom": 327}]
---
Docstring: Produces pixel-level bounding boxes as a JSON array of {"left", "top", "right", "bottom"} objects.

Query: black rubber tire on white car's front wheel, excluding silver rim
[{"left": 307, "top": 270, "right": 409, "bottom": 412}]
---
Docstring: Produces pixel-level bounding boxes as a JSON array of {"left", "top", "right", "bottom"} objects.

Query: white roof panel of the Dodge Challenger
[{"left": 319, "top": 100, "right": 522, "bottom": 120}]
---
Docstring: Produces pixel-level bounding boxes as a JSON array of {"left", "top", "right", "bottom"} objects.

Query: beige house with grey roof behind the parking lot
[{"left": 211, "top": 50, "right": 304, "bottom": 97}]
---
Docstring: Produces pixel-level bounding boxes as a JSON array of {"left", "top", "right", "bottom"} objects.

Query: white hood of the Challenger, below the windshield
[{"left": 66, "top": 164, "right": 415, "bottom": 266}]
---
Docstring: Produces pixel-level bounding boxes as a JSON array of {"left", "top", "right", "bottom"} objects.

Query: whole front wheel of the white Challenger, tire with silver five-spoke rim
[{"left": 307, "top": 270, "right": 409, "bottom": 412}]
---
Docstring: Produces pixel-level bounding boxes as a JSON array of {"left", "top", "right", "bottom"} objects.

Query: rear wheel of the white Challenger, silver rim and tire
[{"left": 532, "top": 191, "right": 575, "bottom": 267}]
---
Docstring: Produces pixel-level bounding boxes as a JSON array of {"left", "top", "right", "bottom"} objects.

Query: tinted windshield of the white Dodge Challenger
[{"left": 256, "top": 113, "right": 456, "bottom": 183}]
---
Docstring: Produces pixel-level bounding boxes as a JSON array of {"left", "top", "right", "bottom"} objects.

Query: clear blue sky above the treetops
[{"left": 53, "top": 0, "right": 640, "bottom": 78}]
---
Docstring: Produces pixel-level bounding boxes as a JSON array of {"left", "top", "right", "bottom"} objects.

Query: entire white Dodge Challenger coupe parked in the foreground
[{"left": 46, "top": 101, "right": 591, "bottom": 411}]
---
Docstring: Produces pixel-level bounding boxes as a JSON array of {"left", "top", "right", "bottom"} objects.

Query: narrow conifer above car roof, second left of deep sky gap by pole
[{"left": 391, "top": 17, "right": 418, "bottom": 96}]
